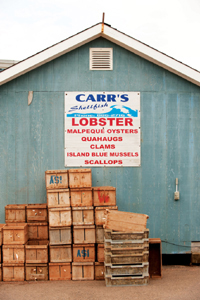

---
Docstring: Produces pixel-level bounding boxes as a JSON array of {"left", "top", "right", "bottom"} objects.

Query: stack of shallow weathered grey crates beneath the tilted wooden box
[{"left": 105, "top": 229, "right": 149, "bottom": 286}]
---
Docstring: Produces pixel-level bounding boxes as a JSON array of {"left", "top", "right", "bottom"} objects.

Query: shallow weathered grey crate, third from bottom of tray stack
[{"left": 104, "top": 251, "right": 149, "bottom": 265}]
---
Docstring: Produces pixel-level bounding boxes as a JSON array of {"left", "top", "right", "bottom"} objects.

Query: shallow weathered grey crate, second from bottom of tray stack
[{"left": 105, "top": 262, "right": 149, "bottom": 276}]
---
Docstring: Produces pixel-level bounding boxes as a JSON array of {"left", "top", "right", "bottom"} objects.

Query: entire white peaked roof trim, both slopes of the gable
[{"left": 0, "top": 23, "right": 200, "bottom": 86}]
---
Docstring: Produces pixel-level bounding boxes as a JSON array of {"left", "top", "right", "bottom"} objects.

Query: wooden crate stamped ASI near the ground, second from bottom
[{"left": 73, "top": 244, "right": 95, "bottom": 262}]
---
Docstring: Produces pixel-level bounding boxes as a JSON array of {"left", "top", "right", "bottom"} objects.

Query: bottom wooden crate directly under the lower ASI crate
[{"left": 72, "top": 262, "right": 94, "bottom": 280}]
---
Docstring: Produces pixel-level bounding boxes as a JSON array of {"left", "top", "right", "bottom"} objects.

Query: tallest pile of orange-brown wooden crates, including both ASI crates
[{"left": 45, "top": 169, "right": 117, "bottom": 280}]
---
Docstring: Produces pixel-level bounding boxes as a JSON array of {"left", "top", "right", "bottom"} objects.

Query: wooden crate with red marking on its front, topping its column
[{"left": 92, "top": 186, "right": 116, "bottom": 206}]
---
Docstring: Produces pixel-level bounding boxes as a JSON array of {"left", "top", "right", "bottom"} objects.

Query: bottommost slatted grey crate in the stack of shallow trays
[{"left": 105, "top": 275, "right": 149, "bottom": 286}]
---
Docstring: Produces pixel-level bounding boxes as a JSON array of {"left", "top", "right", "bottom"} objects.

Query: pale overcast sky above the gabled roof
[{"left": 0, "top": 0, "right": 200, "bottom": 71}]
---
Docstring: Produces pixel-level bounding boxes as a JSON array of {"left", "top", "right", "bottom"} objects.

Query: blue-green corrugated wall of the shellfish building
[{"left": 0, "top": 38, "right": 200, "bottom": 253}]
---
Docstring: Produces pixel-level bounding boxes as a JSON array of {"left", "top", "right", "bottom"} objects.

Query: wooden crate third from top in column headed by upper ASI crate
[{"left": 49, "top": 207, "right": 72, "bottom": 227}]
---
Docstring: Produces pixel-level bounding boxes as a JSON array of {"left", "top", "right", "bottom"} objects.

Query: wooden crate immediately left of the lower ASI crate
[{"left": 49, "top": 245, "right": 72, "bottom": 263}]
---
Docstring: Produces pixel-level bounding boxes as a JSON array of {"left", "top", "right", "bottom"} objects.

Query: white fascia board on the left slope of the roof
[{"left": 0, "top": 24, "right": 101, "bottom": 85}]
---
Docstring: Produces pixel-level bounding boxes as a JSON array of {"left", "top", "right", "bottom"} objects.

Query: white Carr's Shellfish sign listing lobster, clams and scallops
[{"left": 65, "top": 92, "right": 141, "bottom": 167}]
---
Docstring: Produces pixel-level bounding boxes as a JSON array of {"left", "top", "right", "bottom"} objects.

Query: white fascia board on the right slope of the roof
[{"left": 102, "top": 25, "right": 200, "bottom": 86}]
